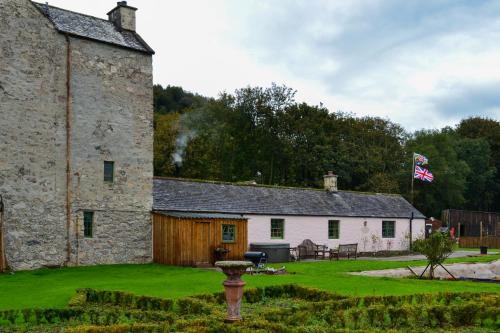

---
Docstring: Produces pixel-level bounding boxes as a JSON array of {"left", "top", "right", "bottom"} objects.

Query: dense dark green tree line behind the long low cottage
[{"left": 154, "top": 84, "right": 500, "bottom": 217}]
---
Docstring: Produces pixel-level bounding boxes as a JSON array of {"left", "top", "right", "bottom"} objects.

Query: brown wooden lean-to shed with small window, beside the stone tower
[{"left": 153, "top": 211, "right": 248, "bottom": 267}]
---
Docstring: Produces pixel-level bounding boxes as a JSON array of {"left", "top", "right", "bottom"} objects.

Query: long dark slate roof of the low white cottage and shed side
[{"left": 153, "top": 178, "right": 425, "bottom": 218}]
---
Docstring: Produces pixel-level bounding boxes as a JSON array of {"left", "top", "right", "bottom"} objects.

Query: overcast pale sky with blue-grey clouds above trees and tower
[{"left": 49, "top": 0, "right": 500, "bottom": 130}]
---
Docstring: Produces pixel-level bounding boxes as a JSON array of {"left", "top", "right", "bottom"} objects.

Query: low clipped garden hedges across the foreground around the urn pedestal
[{"left": 0, "top": 285, "right": 500, "bottom": 333}]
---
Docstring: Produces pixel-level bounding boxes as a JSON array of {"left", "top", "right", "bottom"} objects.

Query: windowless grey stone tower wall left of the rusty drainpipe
[{"left": 0, "top": 0, "right": 66, "bottom": 269}]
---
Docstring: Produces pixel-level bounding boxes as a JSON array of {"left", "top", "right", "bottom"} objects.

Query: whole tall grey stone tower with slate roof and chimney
[{"left": 0, "top": 0, "right": 154, "bottom": 270}]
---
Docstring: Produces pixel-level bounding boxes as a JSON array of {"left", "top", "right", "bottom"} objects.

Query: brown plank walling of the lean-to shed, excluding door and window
[{"left": 153, "top": 213, "right": 248, "bottom": 266}]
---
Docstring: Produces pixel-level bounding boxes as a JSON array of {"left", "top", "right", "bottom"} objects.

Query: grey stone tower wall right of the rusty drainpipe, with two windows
[{"left": 71, "top": 38, "right": 153, "bottom": 264}]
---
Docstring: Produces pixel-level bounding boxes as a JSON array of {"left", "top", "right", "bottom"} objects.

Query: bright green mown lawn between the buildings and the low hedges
[{"left": 0, "top": 255, "right": 500, "bottom": 309}]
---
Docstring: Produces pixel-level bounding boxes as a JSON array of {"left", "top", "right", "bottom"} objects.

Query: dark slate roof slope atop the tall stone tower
[{"left": 33, "top": 2, "right": 154, "bottom": 54}]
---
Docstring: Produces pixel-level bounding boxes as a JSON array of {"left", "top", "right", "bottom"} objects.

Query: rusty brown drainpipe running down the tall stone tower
[{"left": 65, "top": 35, "right": 73, "bottom": 266}]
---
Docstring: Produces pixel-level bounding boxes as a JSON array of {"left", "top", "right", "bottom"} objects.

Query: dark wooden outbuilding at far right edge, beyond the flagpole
[{"left": 442, "top": 209, "right": 500, "bottom": 248}]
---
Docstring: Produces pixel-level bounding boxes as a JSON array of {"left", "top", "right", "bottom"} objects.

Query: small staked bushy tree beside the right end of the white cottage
[{"left": 413, "top": 232, "right": 455, "bottom": 279}]
